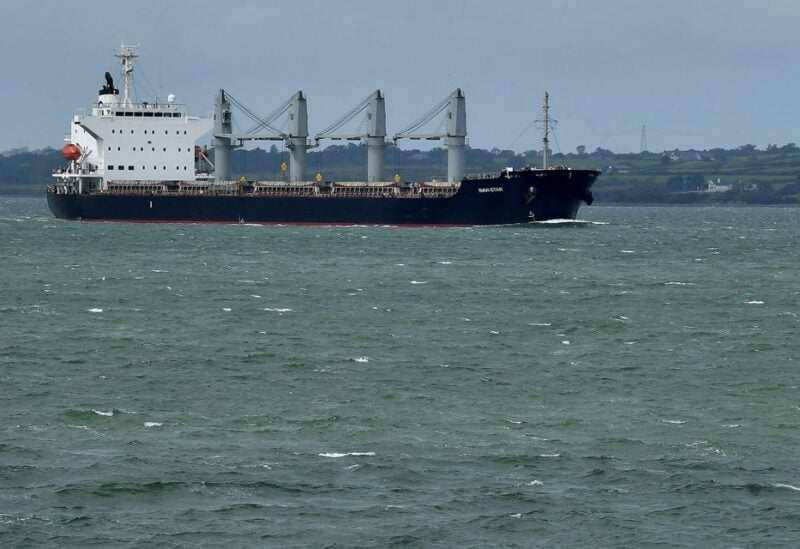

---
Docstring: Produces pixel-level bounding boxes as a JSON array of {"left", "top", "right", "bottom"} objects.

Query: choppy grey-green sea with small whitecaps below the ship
[{"left": 0, "top": 198, "right": 800, "bottom": 547}]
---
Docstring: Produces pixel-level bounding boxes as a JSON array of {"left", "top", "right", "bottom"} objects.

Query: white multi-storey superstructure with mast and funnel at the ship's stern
[{"left": 54, "top": 45, "right": 213, "bottom": 191}]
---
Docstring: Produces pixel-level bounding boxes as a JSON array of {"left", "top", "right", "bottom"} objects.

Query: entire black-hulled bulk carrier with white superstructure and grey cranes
[{"left": 47, "top": 45, "right": 600, "bottom": 226}]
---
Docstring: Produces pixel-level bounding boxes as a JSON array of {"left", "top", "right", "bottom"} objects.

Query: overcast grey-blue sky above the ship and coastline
[{"left": 0, "top": 0, "right": 800, "bottom": 152}]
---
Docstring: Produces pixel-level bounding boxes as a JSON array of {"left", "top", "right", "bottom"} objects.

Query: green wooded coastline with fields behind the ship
[{"left": 0, "top": 143, "right": 800, "bottom": 204}]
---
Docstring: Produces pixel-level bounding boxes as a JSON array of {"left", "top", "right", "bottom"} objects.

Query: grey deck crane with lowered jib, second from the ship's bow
[{"left": 314, "top": 90, "right": 386, "bottom": 183}]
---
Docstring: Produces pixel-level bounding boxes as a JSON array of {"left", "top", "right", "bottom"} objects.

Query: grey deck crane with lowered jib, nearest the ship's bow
[{"left": 394, "top": 88, "right": 467, "bottom": 183}]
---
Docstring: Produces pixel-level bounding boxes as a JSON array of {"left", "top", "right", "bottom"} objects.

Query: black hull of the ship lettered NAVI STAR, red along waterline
[{"left": 47, "top": 169, "right": 599, "bottom": 226}]
